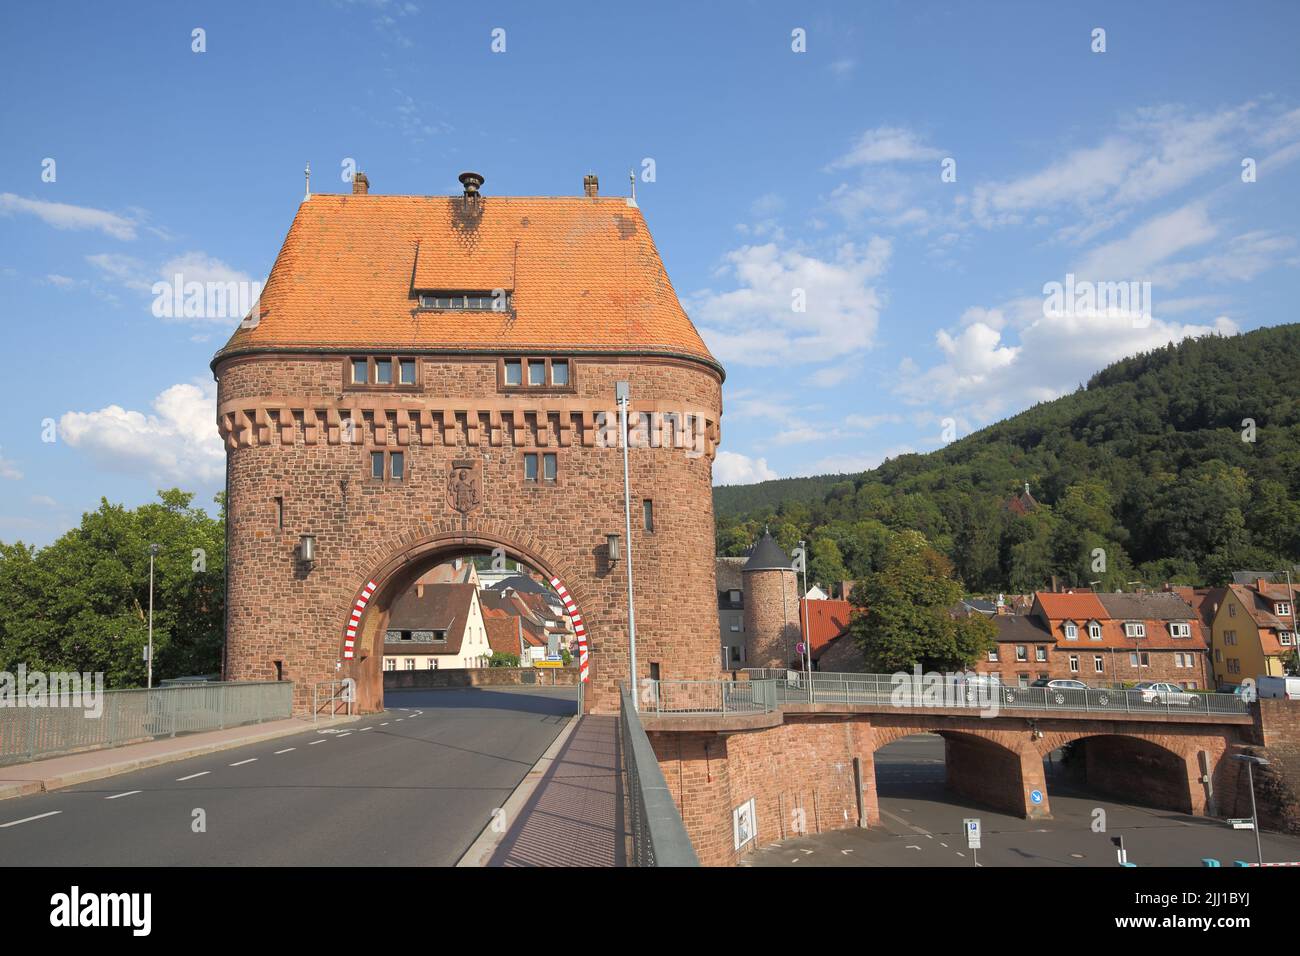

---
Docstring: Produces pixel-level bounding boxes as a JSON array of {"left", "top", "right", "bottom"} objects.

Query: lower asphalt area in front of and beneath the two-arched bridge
[{"left": 746, "top": 735, "right": 1300, "bottom": 866}]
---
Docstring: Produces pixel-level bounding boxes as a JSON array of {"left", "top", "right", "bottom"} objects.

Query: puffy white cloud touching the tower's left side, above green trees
[{"left": 59, "top": 382, "right": 225, "bottom": 484}]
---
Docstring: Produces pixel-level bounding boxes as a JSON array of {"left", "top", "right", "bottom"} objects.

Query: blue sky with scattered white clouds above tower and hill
[{"left": 0, "top": 0, "right": 1300, "bottom": 544}]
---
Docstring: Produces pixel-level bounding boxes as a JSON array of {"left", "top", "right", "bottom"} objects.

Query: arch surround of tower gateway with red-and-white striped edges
[{"left": 338, "top": 533, "right": 590, "bottom": 713}]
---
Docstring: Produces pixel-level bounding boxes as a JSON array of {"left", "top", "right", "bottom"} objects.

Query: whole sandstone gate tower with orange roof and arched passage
[{"left": 212, "top": 174, "right": 723, "bottom": 710}]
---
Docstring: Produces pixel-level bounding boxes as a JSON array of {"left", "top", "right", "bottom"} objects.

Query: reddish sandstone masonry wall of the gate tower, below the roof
[{"left": 217, "top": 356, "right": 720, "bottom": 711}]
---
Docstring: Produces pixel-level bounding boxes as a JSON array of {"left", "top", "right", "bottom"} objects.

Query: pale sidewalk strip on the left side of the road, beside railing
[{"left": 0, "top": 717, "right": 356, "bottom": 800}]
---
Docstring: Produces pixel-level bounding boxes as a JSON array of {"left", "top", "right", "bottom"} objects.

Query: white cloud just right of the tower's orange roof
[{"left": 690, "top": 238, "right": 892, "bottom": 365}]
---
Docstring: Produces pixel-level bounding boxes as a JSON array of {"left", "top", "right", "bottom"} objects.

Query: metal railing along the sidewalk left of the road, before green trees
[{"left": 0, "top": 680, "right": 294, "bottom": 765}]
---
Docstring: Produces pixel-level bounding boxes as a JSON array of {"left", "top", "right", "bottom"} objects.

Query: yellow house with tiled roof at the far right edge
[{"left": 1210, "top": 578, "right": 1296, "bottom": 685}]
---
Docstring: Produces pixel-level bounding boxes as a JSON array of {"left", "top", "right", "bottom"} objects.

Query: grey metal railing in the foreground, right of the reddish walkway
[{"left": 619, "top": 687, "right": 699, "bottom": 866}]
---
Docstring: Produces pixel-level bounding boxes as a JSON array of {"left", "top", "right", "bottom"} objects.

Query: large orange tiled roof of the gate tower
[{"left": 213, "top": 195, "right": 722, "bottom": 372}]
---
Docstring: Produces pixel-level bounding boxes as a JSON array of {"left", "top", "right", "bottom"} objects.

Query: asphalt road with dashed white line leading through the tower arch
[{"left": 0, "top": 688, "right": 576, "bottom": 866}]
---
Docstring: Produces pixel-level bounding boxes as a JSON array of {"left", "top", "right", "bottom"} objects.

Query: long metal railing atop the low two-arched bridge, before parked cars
[{"left": 746, "top": 669, "right": 1251, "bottom": 715}]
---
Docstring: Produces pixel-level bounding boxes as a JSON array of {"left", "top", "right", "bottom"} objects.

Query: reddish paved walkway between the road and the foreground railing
[{"left": 488, "top": 717, "right": 627, "bottom": 866}]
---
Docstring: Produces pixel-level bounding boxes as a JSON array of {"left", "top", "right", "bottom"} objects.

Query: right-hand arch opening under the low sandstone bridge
[{"left": 1040, "top": 734, "right": 1205, "bottom": 813}]
